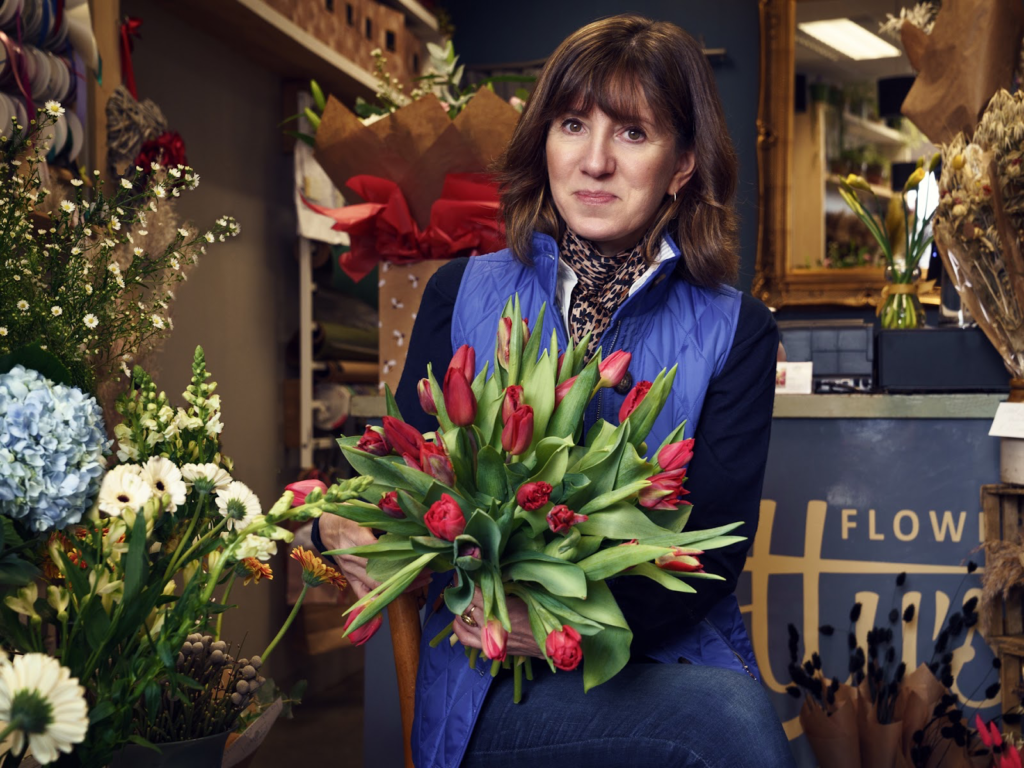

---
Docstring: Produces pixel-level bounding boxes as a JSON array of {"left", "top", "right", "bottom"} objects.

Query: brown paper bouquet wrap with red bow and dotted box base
[{"left": 314, "top": 88, "right": 519, "bottom": 389}]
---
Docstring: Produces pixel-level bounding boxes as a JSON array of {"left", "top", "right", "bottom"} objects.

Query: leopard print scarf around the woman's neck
[{"left": 561, "top": 227, "right": 647, "bottom": 360}]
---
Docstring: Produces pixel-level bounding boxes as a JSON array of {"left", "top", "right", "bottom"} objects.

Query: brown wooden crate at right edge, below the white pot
[{"left": 981, "top": 485, "right": 1024, "bottom": 733}]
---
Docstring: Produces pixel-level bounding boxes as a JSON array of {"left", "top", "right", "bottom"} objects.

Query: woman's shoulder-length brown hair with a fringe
[{"left": 497, "top": 14, "right": 739, "bottom": 287}]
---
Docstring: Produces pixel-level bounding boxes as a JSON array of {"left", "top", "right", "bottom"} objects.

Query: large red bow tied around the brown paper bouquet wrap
[{"left": 302, "top": 173, "right": 505, "bottom": 282}]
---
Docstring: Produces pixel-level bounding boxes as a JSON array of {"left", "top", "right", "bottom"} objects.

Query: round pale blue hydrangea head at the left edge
[{"left": 0, "top": 366, "right": 111, "bottom": 531}]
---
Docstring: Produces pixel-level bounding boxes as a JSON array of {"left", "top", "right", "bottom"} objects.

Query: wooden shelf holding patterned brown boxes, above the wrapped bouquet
[{"left": 153, "top": 0, "right": 374, "bottom": 103}]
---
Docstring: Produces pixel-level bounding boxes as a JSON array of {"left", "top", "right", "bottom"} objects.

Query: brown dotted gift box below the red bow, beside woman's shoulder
[{"left": 378, "top": 259, "right": 445, "bottom": 392}]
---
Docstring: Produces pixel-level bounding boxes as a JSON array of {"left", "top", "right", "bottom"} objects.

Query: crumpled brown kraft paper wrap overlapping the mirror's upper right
[{"left": 900, "top": 0, "right": 1024, "bottom": 144}]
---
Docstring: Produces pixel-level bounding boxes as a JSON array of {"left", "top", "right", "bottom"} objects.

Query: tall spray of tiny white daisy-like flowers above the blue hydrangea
[{"left": 0, "top": 101, "right": 239, "bottom": 390}]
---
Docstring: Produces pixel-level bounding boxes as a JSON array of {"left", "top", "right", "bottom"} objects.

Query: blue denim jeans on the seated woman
[{"left": 462, "top": 659, "right": 794, "bottom": 768}]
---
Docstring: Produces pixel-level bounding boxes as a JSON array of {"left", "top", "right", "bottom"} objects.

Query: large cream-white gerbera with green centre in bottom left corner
[{"left": 0, "top": 653, "right": 89, "bottom": 765}]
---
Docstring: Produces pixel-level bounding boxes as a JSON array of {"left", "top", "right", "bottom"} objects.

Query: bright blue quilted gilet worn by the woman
[{"left": 413, "top": 234, "right": 759, "bottom": 768}]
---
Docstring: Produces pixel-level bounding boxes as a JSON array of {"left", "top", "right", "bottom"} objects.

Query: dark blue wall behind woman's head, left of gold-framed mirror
[{"left": 441, "top": 0, "right": 760, "bottom": 290}]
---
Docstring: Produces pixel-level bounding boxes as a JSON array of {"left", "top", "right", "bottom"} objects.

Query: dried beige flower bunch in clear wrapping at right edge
[{"left": 935, "top": 90, "right": 1024, "bottom": 377}]
